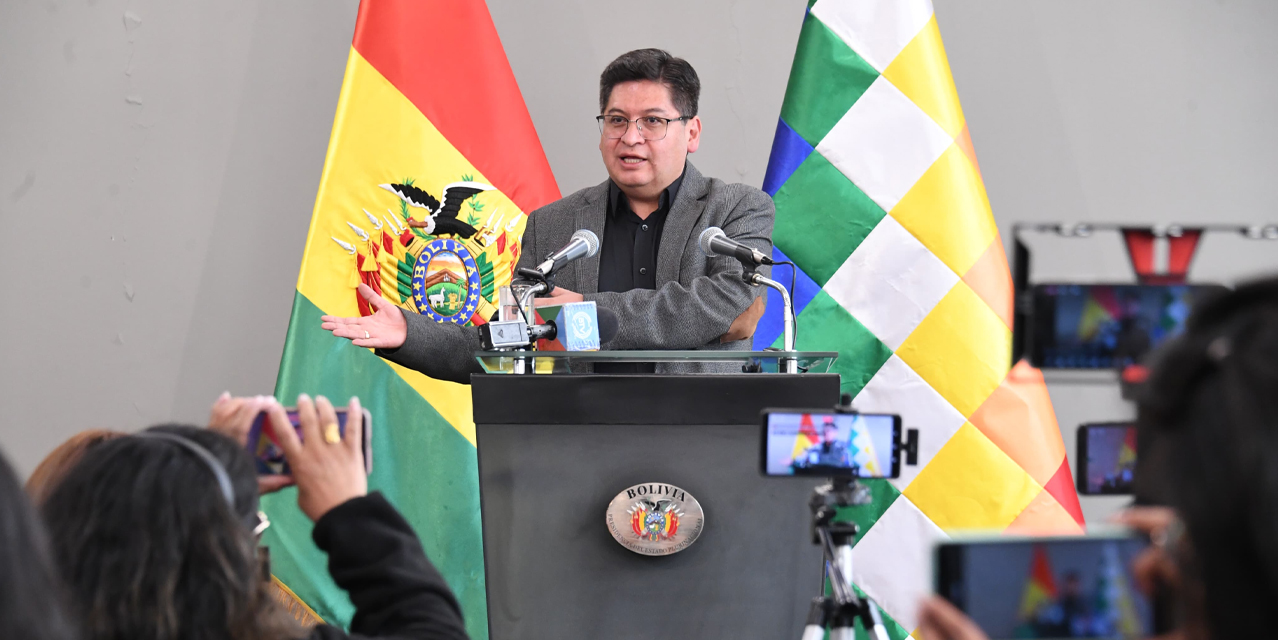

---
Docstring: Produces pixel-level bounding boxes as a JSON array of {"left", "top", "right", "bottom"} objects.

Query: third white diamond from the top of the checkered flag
[{"left": 824, "top": 216, "right": 959, "bottom": 351}]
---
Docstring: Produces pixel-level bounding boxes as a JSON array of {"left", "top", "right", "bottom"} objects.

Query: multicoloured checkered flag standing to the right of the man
[{"left": 755, "top": 0, "right": 1082, "bottom": 637}]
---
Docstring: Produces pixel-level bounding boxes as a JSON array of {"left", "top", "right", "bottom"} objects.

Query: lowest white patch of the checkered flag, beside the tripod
[{"left": 852, "top": 494, "right": 947, "bottom": 632}]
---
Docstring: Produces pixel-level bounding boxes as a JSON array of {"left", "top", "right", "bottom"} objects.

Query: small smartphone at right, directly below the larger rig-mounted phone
[{"left": 1074, "top": 423, "right": 1136, "bottom": 496}]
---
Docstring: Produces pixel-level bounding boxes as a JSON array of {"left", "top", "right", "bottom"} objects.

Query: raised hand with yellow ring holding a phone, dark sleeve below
[{"left": 267, "top": 393, "right": 368, "bottom": 521}]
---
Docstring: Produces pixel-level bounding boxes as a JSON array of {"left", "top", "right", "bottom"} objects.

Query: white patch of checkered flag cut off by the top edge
[{"left": 812, "top": 0, "right": 932, "bottom": 72}]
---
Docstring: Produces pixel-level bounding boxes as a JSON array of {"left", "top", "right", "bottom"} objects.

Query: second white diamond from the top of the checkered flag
[{"left": 817, "top": 77, "right": 953, "bottom": 212}]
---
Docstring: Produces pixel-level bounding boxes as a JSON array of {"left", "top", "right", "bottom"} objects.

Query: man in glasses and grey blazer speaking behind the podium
[{"left": 322, "top": 49, "right": 774, "bottom": 383}]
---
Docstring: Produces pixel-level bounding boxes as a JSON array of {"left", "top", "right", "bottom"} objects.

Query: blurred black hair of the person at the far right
[{"left": 1137, "top": 278, "right": 1278, "bottom": 637}]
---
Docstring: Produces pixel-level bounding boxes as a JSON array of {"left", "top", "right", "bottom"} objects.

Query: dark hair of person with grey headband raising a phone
[{"left": 42, "top": 425, "right": 300, "bottom": 640}]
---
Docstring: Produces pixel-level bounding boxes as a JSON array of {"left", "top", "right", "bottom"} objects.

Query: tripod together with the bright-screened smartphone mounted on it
[{"left": 759, "top": 395, "right": 919, "bottom": 640}]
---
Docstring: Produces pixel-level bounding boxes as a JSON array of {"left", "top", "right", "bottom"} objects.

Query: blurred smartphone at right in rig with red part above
[{"left": 1029, "top": 284, "right": 1224, "bottom": 369}]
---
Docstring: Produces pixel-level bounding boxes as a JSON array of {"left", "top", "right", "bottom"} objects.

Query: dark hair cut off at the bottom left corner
[{"left": 0, "top": 456, "right": 78, "bottom": 640}]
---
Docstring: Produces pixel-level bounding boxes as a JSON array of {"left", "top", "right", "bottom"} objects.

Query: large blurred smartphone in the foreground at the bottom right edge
[{"left": 934, "top": 531, "right": 1164, "bottom": 640}]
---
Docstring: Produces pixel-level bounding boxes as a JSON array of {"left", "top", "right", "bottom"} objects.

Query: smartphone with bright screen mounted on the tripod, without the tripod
[{"left": 759, "top": 409, "right": 901, "bottom": 478}]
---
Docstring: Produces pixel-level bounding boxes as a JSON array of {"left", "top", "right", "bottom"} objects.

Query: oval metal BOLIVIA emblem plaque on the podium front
[{"left": 607, "top": 483, "right": 705, "bottom": 556}]
